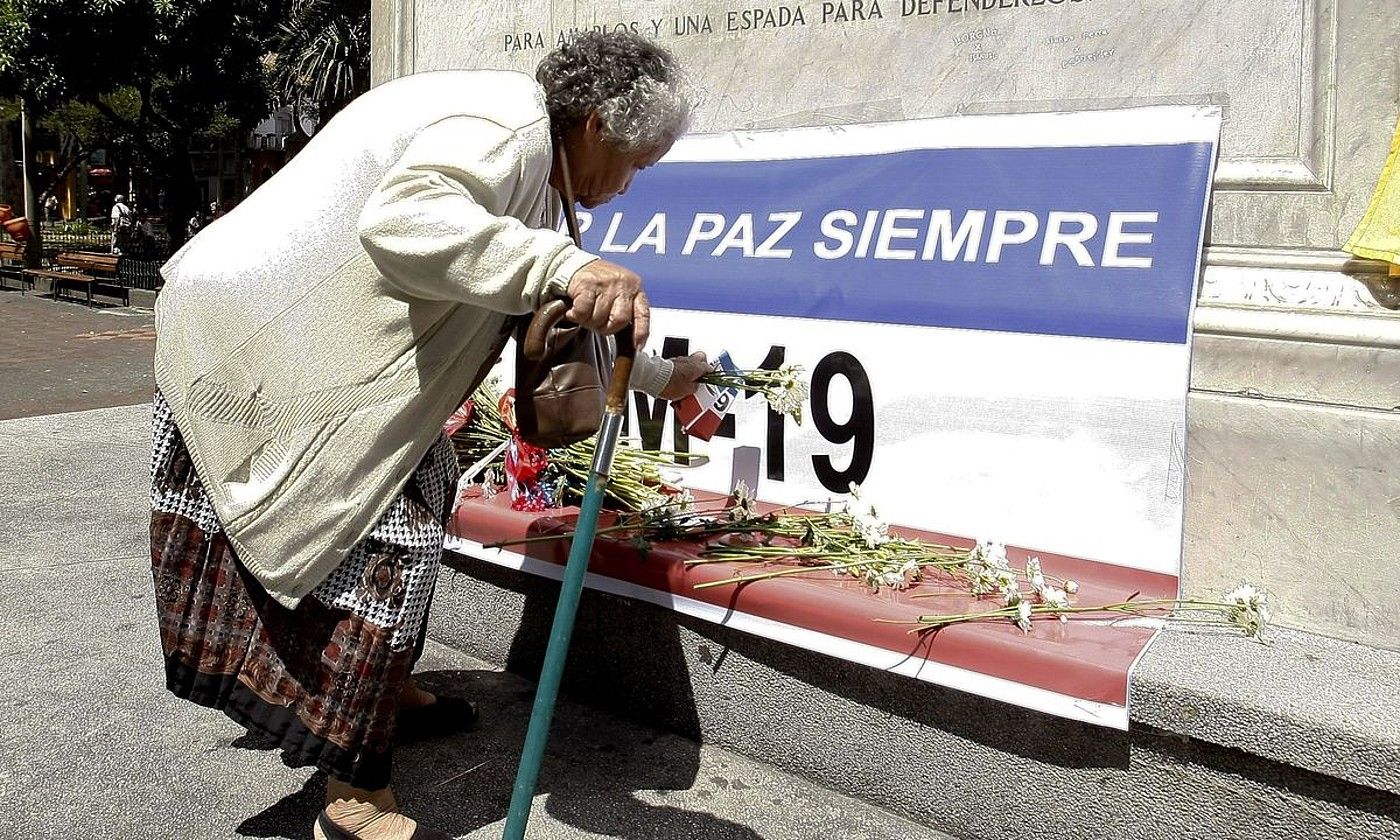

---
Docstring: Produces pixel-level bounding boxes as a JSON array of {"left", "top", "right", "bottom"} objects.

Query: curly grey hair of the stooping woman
[{"left": 535, "top": 31, "right": 690, "bottom": 153}]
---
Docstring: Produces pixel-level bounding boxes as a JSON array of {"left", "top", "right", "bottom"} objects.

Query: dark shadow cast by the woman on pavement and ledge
[{"left": 234, "top": 595, "right": 760, "bottom": 840}]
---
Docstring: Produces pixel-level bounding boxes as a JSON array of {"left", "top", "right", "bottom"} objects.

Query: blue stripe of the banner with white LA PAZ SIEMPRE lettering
[{"left": 584, "top": 143, "right": 1211, "bottom": 343}]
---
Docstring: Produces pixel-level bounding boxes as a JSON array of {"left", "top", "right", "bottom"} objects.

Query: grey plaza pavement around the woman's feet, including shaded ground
[{"left": 0, "top": 309, "right": 946, "bottom": 840}]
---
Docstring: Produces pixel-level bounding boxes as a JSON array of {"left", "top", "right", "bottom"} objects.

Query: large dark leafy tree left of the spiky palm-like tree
[{"left": 0, "top": 0, "right": 284, "bottom": 246}]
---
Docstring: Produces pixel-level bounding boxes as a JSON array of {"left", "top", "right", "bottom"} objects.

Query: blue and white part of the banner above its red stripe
[{"left": 580, "top": 108, "right": 1219, "bottom": 574}]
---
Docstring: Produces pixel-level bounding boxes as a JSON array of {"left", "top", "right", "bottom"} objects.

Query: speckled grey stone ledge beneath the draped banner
[{"left": 430, "top": 554, "right": 1400, "bottom": 840}]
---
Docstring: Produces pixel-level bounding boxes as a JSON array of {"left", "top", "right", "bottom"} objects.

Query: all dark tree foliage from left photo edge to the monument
[{"left": 0, "top": 0, "right": 370, "bottom": 244}]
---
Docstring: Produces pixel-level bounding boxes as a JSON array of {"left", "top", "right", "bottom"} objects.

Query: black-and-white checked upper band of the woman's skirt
[{"left": 151, "top": 393, "right": 458, "bottom": 650}]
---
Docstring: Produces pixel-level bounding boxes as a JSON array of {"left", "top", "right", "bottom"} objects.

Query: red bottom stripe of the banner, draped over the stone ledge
[{"left": 452, "top": 496, "right": 1177, "bottom": 706}]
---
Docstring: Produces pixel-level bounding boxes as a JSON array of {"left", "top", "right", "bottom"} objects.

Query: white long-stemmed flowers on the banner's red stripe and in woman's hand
[{"left": 452, "top": 383, "right": 1270, "bottom": 641}]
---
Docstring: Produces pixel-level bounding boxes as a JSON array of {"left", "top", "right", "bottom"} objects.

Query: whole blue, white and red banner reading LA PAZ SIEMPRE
[{"left": 448, "top": 106, "right": 1219, "bottom": 728}]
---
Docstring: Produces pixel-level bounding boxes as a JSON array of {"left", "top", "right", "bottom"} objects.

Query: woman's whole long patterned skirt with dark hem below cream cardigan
[{"left": 151, "top": 393, "right": 458, "bottom": 790}]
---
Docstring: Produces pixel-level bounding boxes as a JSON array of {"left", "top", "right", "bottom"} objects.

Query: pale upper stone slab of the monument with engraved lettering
[{"left": 413, "top": 0, "right": 1334, "bottom": 189}]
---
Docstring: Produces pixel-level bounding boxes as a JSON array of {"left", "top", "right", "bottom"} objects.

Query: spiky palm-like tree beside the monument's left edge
[{"left": 269, "top": 0, "right": 370, "bottom": 131}]
